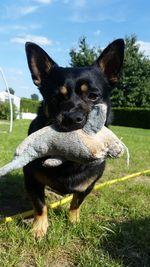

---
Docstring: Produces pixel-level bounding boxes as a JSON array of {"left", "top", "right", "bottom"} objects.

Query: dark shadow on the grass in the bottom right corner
[{"left": 101, "top": 218, "right": 150, "bottom": 267}]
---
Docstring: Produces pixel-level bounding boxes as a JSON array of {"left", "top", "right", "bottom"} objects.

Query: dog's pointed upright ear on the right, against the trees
[{"left": 96, "top": 39, "right": 124, "bottom": 84}]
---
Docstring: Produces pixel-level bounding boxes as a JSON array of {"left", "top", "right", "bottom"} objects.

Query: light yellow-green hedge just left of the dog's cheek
[{"left": 20, "top": 98, "right": 40, "bottom": 113}]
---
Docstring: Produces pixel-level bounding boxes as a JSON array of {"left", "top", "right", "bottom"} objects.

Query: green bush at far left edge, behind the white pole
[{"left": 0, "top": 102, "right": 17, "bottom": 120}]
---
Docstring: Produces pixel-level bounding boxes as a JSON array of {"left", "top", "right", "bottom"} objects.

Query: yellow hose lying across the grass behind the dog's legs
[{"left": 1, "top": 170, "right": 150, "bottom": 222}]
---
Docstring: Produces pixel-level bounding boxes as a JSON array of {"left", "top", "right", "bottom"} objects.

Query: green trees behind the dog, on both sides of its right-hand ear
[{"left": 69, "top": 35, "right": 150, "bottom": 108}]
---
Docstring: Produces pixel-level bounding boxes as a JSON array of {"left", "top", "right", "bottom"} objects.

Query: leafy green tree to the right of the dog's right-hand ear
[{"left": 112, "top": 35, "right": 150, "bottom": 107}]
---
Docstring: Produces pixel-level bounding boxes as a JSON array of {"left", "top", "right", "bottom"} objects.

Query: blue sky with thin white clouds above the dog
[{"left": 0, "top": 0, "right": 150, "bottom": 98}]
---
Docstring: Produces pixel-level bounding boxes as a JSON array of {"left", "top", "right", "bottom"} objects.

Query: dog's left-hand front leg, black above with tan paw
[{"left": 24, "top": 167, "right": 48, "bottom": 239}]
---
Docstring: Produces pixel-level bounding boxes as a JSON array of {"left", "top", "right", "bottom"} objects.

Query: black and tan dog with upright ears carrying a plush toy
[{"left": 23, "top": 39, "right": 124, "bottom": 238}]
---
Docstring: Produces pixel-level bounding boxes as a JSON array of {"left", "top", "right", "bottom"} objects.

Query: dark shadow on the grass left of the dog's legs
[{"left": 0, "top": 174, "right": 31, "bottom": 218}]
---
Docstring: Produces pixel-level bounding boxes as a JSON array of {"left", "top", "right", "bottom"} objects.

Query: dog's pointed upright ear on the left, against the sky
[{"left": 25, "top": 42, "right": 57, "bottom": 87}]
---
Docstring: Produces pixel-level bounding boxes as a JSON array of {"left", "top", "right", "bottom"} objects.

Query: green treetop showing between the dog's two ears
[{"left": 69, "top": 37, "right": 101, "bottom": 67}]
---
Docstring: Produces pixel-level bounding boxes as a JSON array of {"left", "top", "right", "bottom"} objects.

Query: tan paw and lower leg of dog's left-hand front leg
[{"left": 32, "top": 205, "right": 48, "bottom": 239}]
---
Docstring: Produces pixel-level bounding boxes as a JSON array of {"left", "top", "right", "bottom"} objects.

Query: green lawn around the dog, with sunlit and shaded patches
[{"left": 0, "top": 120, "right": 150, "bottom": 267}]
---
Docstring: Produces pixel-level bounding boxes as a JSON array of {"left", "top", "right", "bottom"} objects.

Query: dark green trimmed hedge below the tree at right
[{"left": 112, "top": 108, "right": 150, "bottom": 129}]
